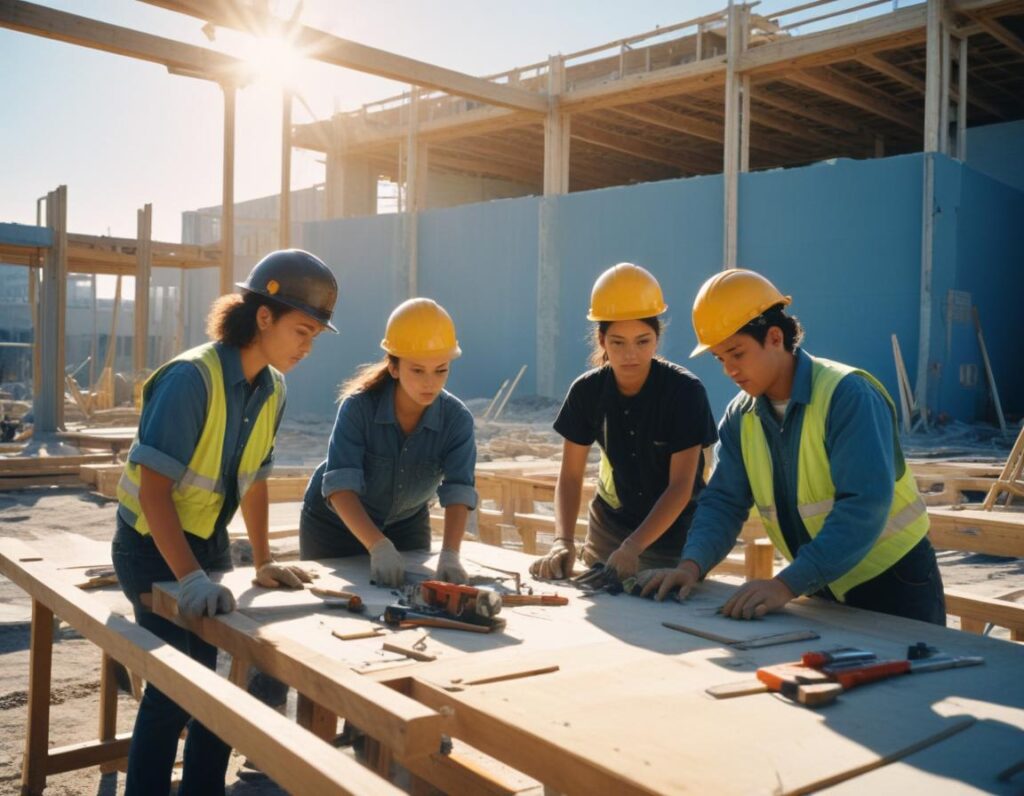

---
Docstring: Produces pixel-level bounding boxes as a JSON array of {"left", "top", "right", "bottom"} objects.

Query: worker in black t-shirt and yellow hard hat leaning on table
[{"left": 530, "top": 262, "right": 716, "bottom": 579}]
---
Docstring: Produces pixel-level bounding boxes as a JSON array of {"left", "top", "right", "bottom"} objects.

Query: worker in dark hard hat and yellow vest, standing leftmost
[{"left": 112, "top": 249, "right": 338, "bottom": 796}]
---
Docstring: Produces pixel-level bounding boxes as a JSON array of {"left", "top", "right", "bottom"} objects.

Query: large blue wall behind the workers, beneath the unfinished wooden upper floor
[{"left": 278, "top": 149, "right": 1024, "bottom": 420}]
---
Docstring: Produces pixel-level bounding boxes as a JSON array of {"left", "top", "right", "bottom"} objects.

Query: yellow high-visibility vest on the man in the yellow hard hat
[{"left": 740, "top": 357, "right": 929, "bottom": 600}]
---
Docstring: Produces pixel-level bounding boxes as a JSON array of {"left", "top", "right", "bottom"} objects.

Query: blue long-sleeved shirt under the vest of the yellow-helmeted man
[{"left": 683, "top": 349, "right": 906, "bottom": 595}]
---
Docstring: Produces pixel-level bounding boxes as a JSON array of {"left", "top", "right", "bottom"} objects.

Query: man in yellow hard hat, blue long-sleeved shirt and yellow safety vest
[{"left": 641, "top": 268, "right": 945, "bottom": 625}]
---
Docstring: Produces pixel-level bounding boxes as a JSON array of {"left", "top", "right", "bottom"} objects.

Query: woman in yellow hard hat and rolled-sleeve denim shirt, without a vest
[{"left": 299, "top": 298, "right": 476, "bottom": 586}]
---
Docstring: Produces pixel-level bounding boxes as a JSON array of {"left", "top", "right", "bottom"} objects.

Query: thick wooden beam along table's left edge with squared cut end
[{"left": 153, "top": 584, "right": 441, "bottom": 756}]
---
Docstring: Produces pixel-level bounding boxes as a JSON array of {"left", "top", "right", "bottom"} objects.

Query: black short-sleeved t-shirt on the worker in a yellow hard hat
[{"left": 554, "top": 359, "right": 718, "bottom": 551}]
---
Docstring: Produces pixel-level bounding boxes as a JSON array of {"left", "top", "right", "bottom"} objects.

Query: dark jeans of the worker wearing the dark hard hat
[{"left": 111, "top": 518, "right": 231, "bottom": 796}]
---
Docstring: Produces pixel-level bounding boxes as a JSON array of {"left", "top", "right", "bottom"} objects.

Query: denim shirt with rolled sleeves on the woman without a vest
[{"left": 322, "top": 381, "right": 476, "bottom": 528}]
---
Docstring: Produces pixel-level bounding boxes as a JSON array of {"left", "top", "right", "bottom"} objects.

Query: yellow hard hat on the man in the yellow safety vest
[{"left": 690, "top": 268, "right": 793, "bottom": 357}]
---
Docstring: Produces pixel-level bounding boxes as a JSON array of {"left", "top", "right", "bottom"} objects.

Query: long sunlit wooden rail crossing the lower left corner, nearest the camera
[{"left": 0, "top": 539, "right": 400, "bottom": 796}]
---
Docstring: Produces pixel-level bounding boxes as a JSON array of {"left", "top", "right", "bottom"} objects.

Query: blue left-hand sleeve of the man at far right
[{"left": 682, "top": 407, "right": 754, "bottom": 577}]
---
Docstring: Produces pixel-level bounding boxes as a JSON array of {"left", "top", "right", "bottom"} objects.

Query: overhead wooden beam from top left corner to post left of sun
[{"left": 0, "top": 0, "right": 243, "bottom": 81}]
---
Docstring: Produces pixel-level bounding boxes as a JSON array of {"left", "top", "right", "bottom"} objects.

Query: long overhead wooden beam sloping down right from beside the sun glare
[{"left": 142, "top": 0, "right": 548, "bottom": 114}]
